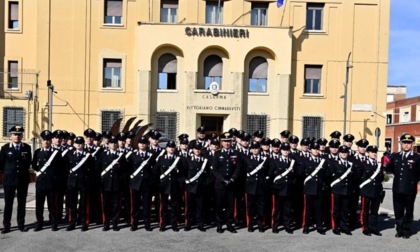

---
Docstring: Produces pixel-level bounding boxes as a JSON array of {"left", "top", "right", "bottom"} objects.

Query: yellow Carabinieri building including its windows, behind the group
[{"left": 0, "top": 0, "right": 390, "bottom": 146}]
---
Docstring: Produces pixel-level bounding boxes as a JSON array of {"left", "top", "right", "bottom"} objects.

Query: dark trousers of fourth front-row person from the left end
[{"left": 102, "top": 191, "right": 121, "bottom": 227}]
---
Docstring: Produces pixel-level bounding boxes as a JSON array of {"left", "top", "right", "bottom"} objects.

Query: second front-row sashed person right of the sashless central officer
[{"left": 269, "top": 142, "right": 298, "bottom": 234}]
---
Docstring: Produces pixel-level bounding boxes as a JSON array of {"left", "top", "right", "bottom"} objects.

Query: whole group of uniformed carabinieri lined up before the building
[{"left": 0, "top": 126, "right": 420, "bottom": 238}]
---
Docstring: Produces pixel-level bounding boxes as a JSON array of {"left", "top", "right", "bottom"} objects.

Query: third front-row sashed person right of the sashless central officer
[{"left": 302, "top": 143, "right": 329, "bottom": 235}]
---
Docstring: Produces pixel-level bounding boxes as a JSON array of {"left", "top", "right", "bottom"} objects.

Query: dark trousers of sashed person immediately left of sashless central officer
[{"left": 184, "top": 192, "right": 204, "bottom": 226}]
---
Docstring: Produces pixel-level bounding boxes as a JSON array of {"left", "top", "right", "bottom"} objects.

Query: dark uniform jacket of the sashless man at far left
[{"left": 0, "top": 143, "right": 32, "bottom": 186}]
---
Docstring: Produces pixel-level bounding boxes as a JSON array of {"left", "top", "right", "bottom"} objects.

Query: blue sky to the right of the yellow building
[{"left": 388, "top": 0, "right": 420, "bottom": 97}]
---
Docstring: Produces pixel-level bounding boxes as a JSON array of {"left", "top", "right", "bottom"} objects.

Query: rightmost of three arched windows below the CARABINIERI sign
[{"left": 248, "top": 57, "right": 268, "bottom": 93}]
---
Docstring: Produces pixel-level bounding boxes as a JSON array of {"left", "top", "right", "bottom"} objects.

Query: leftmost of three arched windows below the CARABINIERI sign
[{"left": 158, "top": 53, "right": 177, "bottom": 89}]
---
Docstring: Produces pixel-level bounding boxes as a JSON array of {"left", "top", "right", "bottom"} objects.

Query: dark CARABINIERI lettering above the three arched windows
[{"left": 185, "top": 27, "right": 249, "bottom": 38}]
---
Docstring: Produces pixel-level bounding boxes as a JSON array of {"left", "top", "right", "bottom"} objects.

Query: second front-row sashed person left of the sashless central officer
[{"left": 155, "top": 140, "right": 183, "bottom": 232}]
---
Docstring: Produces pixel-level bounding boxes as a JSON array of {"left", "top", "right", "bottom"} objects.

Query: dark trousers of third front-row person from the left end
[{"left": 66, "top": 188, "right": 89, "bottom": 225}]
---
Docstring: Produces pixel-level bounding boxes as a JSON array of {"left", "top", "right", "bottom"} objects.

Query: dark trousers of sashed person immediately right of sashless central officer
[{"left": 245, "top": 193, "right": 266, "bottom": 228}]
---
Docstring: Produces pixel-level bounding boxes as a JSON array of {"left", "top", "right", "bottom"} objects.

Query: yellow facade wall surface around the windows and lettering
[{"left": 2, "top": 0, "right": 390, "bottom": 148}]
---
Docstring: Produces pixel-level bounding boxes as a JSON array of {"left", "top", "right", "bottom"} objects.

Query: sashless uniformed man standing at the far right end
[{"left": 387, "top": 134, "right": 420, "bottom": 239}]
